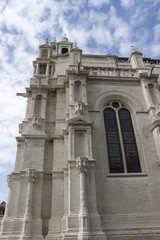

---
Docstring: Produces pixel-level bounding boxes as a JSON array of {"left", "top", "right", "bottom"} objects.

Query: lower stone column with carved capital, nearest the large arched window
[{"left": 76, "top": 157, "right": 90, "bottom": 240}]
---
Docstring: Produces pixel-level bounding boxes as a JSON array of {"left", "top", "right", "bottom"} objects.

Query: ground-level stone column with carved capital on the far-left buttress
[{"left": 21, "top": 169, "right": 37, "bottom": 239}]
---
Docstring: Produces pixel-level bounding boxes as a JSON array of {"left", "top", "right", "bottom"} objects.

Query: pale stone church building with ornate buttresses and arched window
[{"left": 0, "top": 36, "right": 160, "bottom": 240}]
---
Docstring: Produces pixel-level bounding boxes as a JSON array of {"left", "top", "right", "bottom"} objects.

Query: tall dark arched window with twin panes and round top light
[{"left": 104, "top": 102, "right": 141, "bottom": 173}]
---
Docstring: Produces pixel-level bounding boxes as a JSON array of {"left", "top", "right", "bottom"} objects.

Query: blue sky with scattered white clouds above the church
[{"left": 0, "top": 0, "right": 160, "bottom": 202}]
